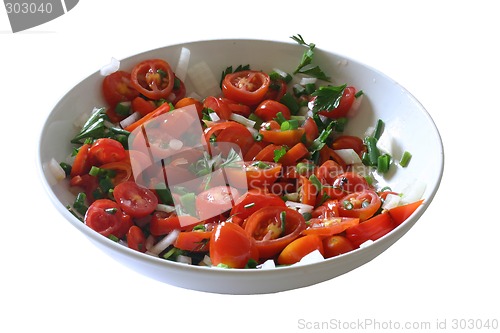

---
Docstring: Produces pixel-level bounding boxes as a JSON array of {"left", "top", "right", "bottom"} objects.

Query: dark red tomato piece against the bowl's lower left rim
[{"left": 84, "top": 199, "right": 132, "bottom": 238}]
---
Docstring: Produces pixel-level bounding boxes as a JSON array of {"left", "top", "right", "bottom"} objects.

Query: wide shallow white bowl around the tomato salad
[{"left": 39, "top": 40, "right": 444, "bottom": 294}]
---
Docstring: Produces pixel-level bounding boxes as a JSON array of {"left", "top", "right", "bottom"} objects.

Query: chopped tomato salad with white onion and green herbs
[{"left": 53, "top": 35, "right": 423, "bottom": 268}]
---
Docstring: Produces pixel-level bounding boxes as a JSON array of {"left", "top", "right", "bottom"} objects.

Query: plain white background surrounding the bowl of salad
[{"left": 0, "top": 0, "right": 500, "bottom": 332}]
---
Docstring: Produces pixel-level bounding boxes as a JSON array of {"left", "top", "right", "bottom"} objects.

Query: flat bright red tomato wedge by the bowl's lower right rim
[{"left": 345, "top": 213, "right": 396, "bottom": 248}]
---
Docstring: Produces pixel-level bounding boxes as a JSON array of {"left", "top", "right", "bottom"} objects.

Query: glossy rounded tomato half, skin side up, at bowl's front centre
[{"left": 209, "top": 222, "right": 259, "bottom": 268}]
